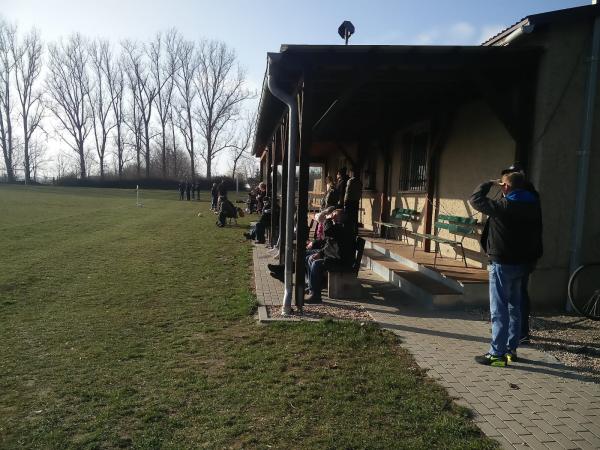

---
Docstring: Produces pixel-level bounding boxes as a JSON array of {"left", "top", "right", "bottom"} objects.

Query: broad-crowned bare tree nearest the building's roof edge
[{"left": 195, "top": 41, "right": 251, "bottom": 180}]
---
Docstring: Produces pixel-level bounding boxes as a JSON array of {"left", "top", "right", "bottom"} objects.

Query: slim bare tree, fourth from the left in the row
[{"left": 88, "top": 40, "right": 115, "bottom": 179}]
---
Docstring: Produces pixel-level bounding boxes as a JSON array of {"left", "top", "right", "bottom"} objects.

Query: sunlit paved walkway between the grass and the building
[{"left": 254, "top": 247, "right": 600, "bottom": 449}]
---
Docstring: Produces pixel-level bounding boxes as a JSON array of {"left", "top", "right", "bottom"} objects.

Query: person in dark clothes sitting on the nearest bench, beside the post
[{"left": 305, "top": 209, "right": 355, "bottom": 304}]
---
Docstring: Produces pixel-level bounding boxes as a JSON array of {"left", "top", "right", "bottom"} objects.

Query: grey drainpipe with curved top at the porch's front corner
[{"left": 267, "top": 59, "right": 298, "bottom": 316}]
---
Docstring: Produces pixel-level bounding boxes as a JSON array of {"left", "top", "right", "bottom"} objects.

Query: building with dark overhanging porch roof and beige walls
[{"left": 253, "top": 5, "right": 600, "bottom": 307}]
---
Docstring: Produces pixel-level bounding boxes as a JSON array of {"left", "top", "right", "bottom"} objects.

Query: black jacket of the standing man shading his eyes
[{"left": 469, "top": 181, "right": 543, "bottom": 264}]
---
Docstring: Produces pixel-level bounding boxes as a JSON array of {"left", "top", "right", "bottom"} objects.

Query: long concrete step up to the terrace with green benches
[{"left": 362, "top": 245, "right": 487, "bottom": 307}]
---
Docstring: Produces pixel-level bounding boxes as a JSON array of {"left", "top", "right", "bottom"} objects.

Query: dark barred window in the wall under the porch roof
[{"left": 399, "top": 131, "right": 429, "bottom": 192}]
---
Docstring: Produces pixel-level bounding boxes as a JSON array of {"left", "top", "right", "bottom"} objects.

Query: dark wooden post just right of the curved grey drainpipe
[{"left": 295, "top": 72, "right": 313, "bottom": 308}]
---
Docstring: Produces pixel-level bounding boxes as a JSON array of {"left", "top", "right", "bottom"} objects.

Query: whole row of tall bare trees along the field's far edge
[{"left": 0, "top": 19, "right": 254, "bottom": 181}]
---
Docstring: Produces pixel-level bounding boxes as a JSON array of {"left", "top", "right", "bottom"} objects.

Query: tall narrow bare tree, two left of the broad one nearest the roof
[{"left": 148, "top": 30, "right": 181, "bottom": 178}]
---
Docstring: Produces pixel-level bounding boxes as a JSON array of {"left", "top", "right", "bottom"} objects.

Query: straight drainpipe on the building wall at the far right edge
[{"left": 567, "top": 16, "right": 600, "bottom": 310}]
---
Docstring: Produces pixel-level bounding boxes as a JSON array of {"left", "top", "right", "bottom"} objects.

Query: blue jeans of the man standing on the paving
[{"left": 488, "top": 262, "right": 527, "bottom": 356}]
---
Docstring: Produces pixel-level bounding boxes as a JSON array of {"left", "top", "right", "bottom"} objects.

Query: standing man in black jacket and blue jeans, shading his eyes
[{"left": 469, "top": 172, "right": 542, "bottom": 366}]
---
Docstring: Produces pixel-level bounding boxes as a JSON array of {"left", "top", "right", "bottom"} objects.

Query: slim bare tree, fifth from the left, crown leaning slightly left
[{"left": 102, "top": 46, "right": 125, "bottom": 178}]
